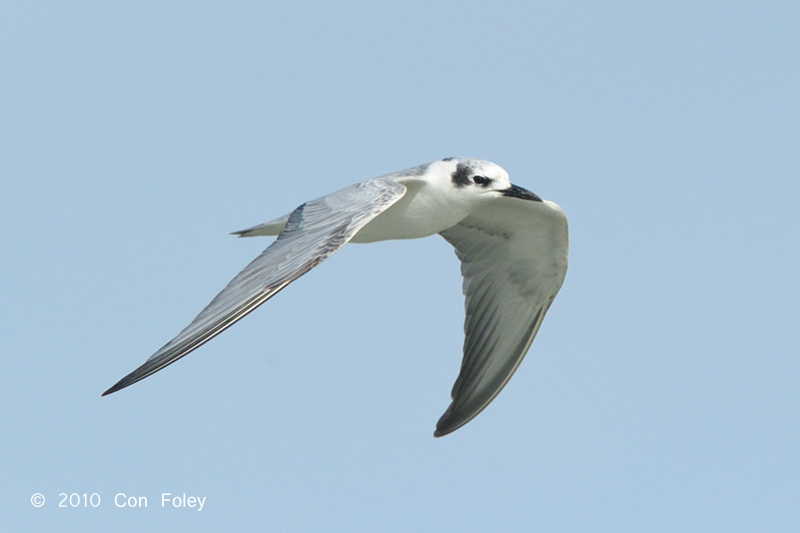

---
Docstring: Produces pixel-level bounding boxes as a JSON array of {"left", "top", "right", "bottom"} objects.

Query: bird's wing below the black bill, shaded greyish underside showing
[{"left": 434, "top": 197, "right": 568, "bottom": 437}]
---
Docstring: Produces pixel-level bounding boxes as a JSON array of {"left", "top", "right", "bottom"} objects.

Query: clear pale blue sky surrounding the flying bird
[{"left": 0, "top": 0, "right": 800, "bottom": 531}]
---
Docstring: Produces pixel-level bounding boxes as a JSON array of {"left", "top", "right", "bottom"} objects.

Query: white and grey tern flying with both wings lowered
[{"left": 103, "top": 157, "right": 568, "bottom": 437}]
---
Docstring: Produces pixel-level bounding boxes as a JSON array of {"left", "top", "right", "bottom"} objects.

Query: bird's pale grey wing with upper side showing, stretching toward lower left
[{"left": 103, "top": 178, "right": 406, "bottom": 396}]
